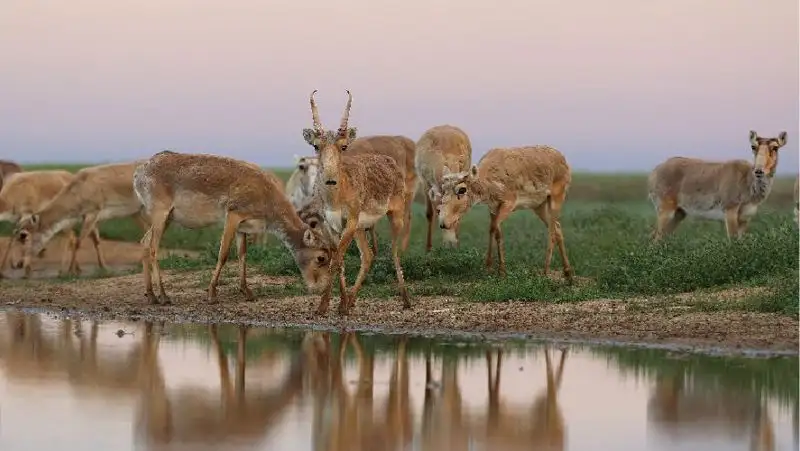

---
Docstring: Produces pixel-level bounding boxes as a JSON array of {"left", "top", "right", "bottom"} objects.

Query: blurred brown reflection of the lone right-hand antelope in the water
[{"left": 647, "top": 372, "right": 784, "bottom": 451}]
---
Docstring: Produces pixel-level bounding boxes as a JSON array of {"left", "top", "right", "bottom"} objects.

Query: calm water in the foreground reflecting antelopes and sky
[{"left": 0, "top": 311, "right": 798, "bottom": 451}]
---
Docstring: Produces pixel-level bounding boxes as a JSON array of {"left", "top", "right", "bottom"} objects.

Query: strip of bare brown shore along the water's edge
[{"left": 0, "top": 265, "right": 798, "bottom": 354}]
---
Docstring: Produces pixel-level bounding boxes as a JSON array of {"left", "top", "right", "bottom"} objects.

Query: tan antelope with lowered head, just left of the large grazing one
[{"left": 16, "top": 161, "right": 148, "bottom": 274}]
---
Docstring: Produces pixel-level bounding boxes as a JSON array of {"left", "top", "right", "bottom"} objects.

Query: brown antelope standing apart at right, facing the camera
[{"left": 648, "top": 130, "right": 786, "bottom": 241}]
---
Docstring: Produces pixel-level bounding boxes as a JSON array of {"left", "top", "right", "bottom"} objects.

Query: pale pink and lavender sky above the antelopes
[{"left": 0, "top": 0, "right": 800, "bottom": 174}]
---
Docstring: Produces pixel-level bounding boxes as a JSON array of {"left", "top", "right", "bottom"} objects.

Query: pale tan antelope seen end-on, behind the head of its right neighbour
[{"left": 415, "top": 125, "right": 472, "bottom": 251}]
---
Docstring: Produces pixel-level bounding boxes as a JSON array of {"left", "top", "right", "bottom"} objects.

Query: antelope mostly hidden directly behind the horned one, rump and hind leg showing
[{"left": 303, "top": 123, "right": 417, "bottom": 254}]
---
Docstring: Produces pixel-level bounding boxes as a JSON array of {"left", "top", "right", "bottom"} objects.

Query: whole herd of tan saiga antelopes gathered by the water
[{"left": 0, "top": 90, "right": 800, "bottom": 315}]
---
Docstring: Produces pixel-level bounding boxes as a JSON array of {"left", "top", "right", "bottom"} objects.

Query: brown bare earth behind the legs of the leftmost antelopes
[{"left": 0, "top": 236, "right": 199, "bottom": 279}]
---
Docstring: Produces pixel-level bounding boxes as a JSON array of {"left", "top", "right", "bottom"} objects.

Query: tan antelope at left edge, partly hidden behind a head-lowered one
[{"left": 0, "top": 170, "right": 86, "bottom": 277}]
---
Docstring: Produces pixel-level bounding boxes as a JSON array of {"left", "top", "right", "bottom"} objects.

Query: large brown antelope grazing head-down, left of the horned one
[{"left": 133, "top": 151, "right": 330, "bottom": 304}]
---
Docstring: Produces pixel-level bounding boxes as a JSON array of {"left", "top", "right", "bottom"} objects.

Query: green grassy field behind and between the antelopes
[{"left": 6, "top": 165, "right": 798, "bottom": 315}]
